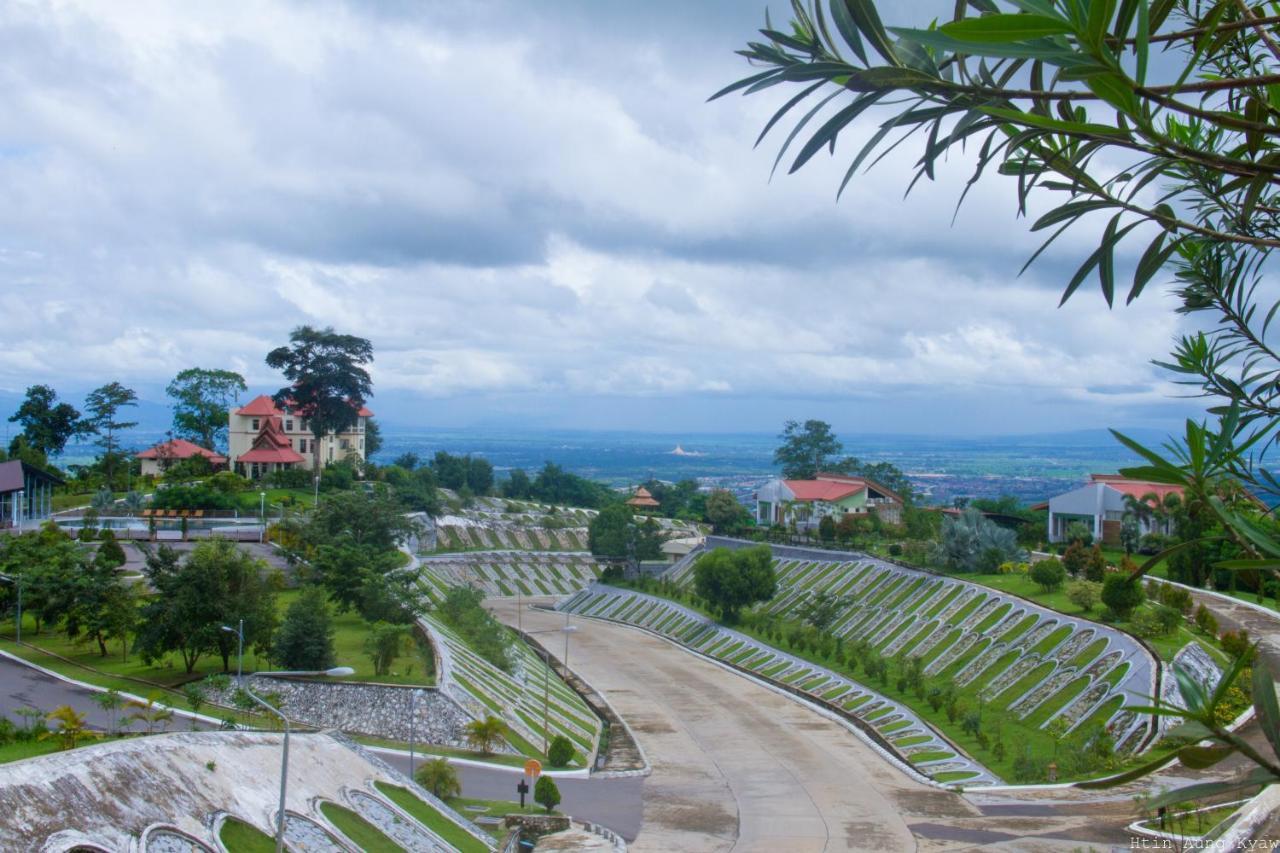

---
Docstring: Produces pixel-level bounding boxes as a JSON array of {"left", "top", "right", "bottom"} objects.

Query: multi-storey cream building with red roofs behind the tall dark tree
[{"left": 228, "top": 394, "right": 374, "bottom": 479}]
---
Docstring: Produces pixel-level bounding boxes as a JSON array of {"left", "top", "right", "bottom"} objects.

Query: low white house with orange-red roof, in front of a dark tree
[{"left": 755, "top": 474, "right": 902, "bottom": 529}]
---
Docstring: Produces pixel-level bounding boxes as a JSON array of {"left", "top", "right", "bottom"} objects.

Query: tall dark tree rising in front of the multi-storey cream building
[{"left": 266, "top": 325, "right": 374, "bottom": 470}]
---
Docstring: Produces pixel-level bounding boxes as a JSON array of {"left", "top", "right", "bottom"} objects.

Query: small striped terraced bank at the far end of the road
[{"left": 420, "top": 551, "right": 600, "bottom": 599}]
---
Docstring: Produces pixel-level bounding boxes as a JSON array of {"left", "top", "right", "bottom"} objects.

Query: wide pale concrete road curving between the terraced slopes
[{"left": 492, "top": 601, "right": 1132, "bottom": 852}]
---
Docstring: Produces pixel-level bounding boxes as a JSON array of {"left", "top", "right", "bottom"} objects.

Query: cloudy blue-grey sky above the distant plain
[{"left": 0, "top": 0, "right": 1196, "bottom": 434}]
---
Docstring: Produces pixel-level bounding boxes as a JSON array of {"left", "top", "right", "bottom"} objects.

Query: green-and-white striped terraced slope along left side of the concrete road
[{"left": 419, "top": 613, "right": 603, "bottom": 765}]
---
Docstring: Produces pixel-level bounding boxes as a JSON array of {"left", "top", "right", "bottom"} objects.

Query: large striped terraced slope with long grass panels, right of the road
[{"left": 742, "top": 548, "right": 1158, "bottom": 752}]
